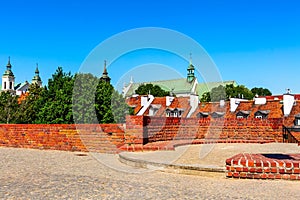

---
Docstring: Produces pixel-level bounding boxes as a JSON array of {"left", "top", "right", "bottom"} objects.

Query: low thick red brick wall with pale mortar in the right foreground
[{"left": 226, "top": 153, "right": 300, "bottom": 180}]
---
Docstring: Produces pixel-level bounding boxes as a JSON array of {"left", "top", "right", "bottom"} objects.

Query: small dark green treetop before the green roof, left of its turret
[{"left": 135, "top": 83, "right": 170, "bottom": 97}]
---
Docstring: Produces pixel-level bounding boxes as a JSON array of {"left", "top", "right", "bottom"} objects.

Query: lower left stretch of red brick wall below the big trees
[{"left": 0, "top": 124, "right": 124, "bottom": 153}]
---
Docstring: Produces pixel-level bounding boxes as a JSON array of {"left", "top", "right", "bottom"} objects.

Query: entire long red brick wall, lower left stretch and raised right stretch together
[{"left": 0, "top": 116, "right": 282, "bottom": 153}]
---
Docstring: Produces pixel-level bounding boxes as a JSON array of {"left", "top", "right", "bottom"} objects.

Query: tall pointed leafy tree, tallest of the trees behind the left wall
[{"left": 37, "top": 67, "right": 74, "bottom": 124}]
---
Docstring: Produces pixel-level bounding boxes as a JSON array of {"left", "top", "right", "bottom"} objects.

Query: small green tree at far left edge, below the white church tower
[{"left": 0, "top": 92, "right": 18, "bottom": 124}]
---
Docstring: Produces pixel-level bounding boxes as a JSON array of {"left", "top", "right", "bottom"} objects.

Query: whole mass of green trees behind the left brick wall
[{"left": 0, "top": 67, "right": 130, "bottom": 124}]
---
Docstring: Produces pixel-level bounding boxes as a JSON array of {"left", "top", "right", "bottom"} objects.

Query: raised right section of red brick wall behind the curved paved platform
[{"left": 144, "top": 117, "right": 282, "bottom": 142}]
